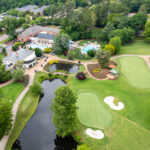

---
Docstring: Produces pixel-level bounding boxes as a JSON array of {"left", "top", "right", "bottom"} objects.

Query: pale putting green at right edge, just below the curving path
[{"left": 119, "top": 56, "right": 150, "bottom": 88}]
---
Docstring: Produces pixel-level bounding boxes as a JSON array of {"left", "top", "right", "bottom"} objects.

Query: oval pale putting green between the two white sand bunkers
[{"left": 77, "top": 92, "right": 112, "bottom": 129}]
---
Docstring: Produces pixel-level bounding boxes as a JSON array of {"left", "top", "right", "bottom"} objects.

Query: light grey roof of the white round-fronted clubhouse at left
[{"left": 3, "top": 49, "right": 35, "bottom": 63}]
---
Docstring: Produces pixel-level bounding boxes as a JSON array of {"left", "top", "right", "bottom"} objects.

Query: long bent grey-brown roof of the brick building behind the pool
[{"left": 19, "top": 25, "right": 60, "bottom": 38}]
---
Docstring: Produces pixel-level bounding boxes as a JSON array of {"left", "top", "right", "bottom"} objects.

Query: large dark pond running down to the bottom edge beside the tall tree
[{"left": 14, "top": 79, "right": 77, "bottom": 150}]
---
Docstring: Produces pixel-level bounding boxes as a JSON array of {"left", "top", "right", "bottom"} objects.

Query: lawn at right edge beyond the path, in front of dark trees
[{"left": 120, "top": 40, "right": 150, "bottom": 55}]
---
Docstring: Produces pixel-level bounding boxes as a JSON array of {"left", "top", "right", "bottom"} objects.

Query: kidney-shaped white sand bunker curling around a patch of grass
[{"left": 104, "top": 96, "right": 124, "bottom": 110}]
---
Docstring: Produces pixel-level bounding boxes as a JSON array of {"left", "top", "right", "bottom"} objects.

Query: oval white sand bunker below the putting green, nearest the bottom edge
[{"left": 86, "top": 128, "right": 104, "bottom": 139}]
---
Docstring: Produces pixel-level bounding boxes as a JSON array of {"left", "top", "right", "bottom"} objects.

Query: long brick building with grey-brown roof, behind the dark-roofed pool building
[{"left": 17, "top": 25, "right": 60, "bottom": 42}]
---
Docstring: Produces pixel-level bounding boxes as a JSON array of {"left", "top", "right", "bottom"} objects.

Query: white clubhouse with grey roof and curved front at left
[{"left": 3, "top": 49, "right": 36, "bottom": 68}]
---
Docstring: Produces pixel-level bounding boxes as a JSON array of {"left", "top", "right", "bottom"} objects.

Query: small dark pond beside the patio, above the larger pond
[{"left": 50, "top": 63, "right": 79, "bottom": 73}]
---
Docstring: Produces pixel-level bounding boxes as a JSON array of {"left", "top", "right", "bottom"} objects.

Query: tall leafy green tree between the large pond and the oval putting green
[{"left": 51, "top": 86, "right": 77, "bottom": 137}]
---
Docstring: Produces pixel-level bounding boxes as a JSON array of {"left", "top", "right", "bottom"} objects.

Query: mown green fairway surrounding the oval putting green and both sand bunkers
[{"left": 69, "top": 56, "right": 150, "bottom": 150}]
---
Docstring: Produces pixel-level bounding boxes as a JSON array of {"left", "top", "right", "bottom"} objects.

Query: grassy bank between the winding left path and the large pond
[{"left": 6, "top": 72, "right": 48, "bottom": 150}]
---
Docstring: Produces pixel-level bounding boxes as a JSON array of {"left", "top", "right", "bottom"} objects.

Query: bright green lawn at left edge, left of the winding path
[{"left": 0, "top": 82, "right": 24, "bottom": 107}]
